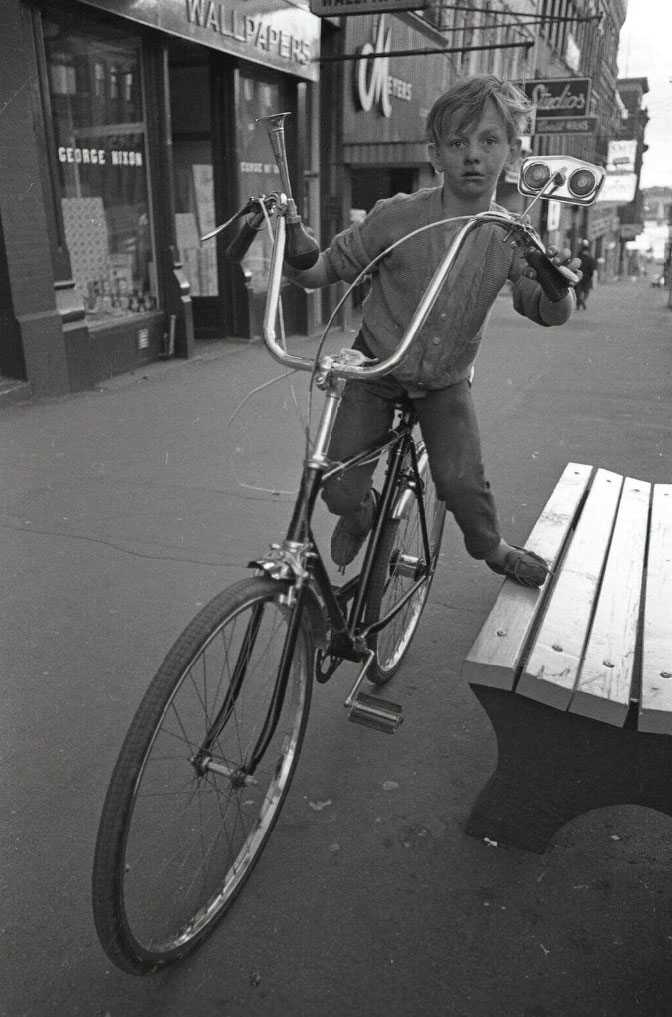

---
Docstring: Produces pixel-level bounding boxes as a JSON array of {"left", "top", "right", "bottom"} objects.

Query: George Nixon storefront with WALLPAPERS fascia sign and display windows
[{"left": 0, "top": 0, "right": 320, "bottom": 394}]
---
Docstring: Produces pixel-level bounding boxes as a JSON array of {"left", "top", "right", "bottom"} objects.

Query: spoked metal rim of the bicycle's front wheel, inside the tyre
[{"left": 119, "top": 599, "right": 309, "bottom": 957}]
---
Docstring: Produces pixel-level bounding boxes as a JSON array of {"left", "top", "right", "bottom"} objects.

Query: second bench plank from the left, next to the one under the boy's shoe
[{"left": 515, "top": 470, "right": 623, "bottom": 710}]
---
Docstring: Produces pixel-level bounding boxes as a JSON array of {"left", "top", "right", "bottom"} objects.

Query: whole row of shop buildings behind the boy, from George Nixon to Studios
[{"left": 0, "top": 0, "right": 626, "bottom": 395}]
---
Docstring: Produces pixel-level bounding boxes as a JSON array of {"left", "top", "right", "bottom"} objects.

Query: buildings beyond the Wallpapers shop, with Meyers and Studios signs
[{"left": 320, "top": 0, "right": 626, "bottom": 323}]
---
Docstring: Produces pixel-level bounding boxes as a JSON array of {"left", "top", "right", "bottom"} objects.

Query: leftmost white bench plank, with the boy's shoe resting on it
[{"left": 462, "top": 463, "right": 593, "bottom": 690}]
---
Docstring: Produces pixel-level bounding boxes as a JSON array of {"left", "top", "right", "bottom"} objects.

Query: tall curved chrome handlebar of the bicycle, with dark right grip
[{"left": 263, "top": 212, "right": 579, "bottom": 380}]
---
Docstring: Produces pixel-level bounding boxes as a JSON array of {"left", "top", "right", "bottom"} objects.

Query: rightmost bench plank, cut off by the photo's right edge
[{"left": 637, "top": 484, "right": 672, "bottom": 734}]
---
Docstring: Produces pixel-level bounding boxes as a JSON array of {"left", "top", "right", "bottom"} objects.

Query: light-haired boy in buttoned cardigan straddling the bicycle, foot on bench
[{"left": 287, "top": 75, "right": 577, "bottom": 587}]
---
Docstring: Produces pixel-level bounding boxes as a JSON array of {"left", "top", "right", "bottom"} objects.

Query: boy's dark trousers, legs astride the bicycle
[{"left": 322, "top": 341, "right": 500, "bottom": 559}]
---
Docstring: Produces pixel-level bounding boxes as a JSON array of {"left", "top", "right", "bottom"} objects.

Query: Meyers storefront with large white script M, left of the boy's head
[{"left": 313, "top": 13, "right": 453, "bottom": 326}]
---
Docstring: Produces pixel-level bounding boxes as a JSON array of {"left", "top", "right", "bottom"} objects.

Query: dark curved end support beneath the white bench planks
[{"left": 466, "top": 684, "right": 672, "bottom": 853}]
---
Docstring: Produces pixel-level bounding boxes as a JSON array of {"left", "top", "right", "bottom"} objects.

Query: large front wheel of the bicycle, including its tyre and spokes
[{"left": 93, "top": 578, "right": 313, "bottom": 974}]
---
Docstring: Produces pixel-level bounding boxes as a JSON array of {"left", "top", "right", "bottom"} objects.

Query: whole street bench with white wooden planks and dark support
[{"left": 463, "top": 463, "right": 672, "bottom": 851}]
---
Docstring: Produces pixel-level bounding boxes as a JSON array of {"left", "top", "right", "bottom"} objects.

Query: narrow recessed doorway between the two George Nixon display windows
[{"left": 169, "top": 43, "right": 221, "bottom": 339}]
